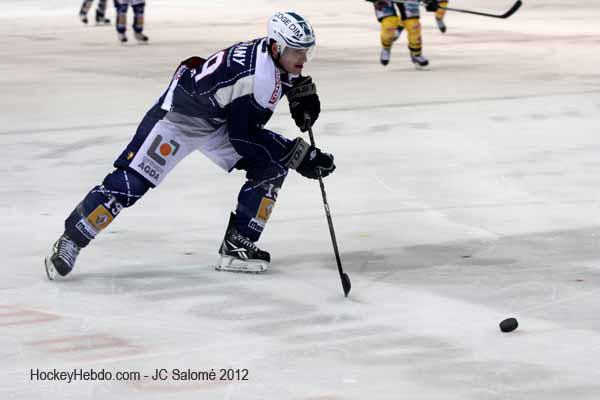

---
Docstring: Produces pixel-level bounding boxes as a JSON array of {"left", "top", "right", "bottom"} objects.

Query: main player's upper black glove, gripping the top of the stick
[{"left": 287, "top": 76, "right": 321, "bottom": 132}]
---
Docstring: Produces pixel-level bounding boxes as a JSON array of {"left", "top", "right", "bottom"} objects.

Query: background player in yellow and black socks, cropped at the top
[{"left": 367, "top": 0, "right": 438, "bottom": 69}]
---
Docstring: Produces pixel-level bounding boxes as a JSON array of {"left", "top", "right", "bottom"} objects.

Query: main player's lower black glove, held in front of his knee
[{"left": 280, "top": 138, "right": 335, "bottom": 179}]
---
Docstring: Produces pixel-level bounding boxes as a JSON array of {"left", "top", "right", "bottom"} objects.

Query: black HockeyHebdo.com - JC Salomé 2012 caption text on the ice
[{"left": 29, "top": 368, "right": 250, "bottom": 383}]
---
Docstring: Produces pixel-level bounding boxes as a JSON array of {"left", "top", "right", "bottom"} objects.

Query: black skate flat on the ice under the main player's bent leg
[{"left": 215, "top": 213, "right": 271, "bottom": 272}]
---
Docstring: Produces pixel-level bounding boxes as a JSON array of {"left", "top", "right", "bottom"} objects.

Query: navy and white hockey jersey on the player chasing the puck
[{"left": 149, "top": 38, "right": 291, "bottom": 167}]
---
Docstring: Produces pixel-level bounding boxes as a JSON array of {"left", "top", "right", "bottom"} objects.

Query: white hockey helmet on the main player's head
[{"left": 267, "top": 11, "right": 316, "bottom": 60}]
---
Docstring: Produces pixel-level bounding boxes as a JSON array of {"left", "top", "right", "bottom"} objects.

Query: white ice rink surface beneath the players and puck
[{"left": 0, "top": 0, "right": 600, "bottom": 400}]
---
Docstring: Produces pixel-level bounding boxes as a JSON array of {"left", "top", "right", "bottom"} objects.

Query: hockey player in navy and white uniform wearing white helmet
[{"left": 45, "top": 12, "right": 335, "bottom": 280}]
